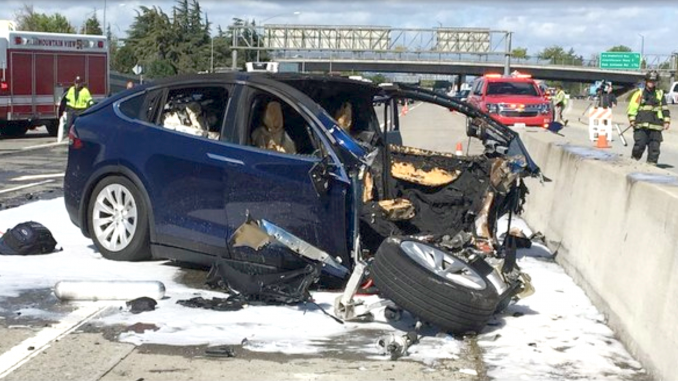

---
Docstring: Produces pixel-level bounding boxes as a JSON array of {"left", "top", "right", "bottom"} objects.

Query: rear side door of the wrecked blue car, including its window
[{"left": 121, "top": 83, "right": 238, "bottom": 264}]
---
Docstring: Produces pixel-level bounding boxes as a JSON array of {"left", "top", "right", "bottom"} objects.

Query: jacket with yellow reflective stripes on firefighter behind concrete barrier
[{"left": 627, "top": 89, "right": 671, "bottom": 131}]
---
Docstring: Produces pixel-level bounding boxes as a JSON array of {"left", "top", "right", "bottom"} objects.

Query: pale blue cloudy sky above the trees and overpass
[{"left": 0, "top": 0, "right": 678, "bottom": 59}]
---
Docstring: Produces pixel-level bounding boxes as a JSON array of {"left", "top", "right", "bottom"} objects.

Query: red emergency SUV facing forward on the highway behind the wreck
[{"left": 468, "top": 74, "right": 553, "bottom": 127}]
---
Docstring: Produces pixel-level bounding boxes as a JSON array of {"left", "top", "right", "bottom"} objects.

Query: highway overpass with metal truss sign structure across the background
[{"left": 229, "top": 24, "right": 676, "bottom": 86}]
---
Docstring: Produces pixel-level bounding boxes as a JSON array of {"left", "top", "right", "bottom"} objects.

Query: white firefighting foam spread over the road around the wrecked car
[{"left": 0, "top": 198, "right": 648, "bottom": 381}]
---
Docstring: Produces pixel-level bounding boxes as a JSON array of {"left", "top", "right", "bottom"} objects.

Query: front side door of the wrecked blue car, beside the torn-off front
[{"left": 226, "top": 86, "right": 350, "bottom": 260}]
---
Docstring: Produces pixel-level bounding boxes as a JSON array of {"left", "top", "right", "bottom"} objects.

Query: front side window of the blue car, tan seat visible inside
[{"left": 245, "top": 92, "right": 321, "bottom": 155}]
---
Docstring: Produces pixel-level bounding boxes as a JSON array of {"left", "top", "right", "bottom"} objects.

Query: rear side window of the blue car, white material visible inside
[{"left": 157, "top": 86, "right": 228, "bottom": 140}]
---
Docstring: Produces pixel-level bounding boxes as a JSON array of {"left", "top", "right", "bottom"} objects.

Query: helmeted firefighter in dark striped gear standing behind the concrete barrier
[{"left": 627, "top": 70, "right": 671, "bottom": 165}]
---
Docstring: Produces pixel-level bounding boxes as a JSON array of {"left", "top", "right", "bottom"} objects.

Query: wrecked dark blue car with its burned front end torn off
[{"left": 64, "top": 73, "right": 539, "bottom": 333}]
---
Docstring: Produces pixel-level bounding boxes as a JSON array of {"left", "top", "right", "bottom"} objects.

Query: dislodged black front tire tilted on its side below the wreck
[{"left": 371, "top": 238, "right": 499, "bottom": 334}]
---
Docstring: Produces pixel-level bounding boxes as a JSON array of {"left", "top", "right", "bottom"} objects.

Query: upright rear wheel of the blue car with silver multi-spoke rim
[{"left": 87, "top": 176, "right": 151, "bottom": 261}]
